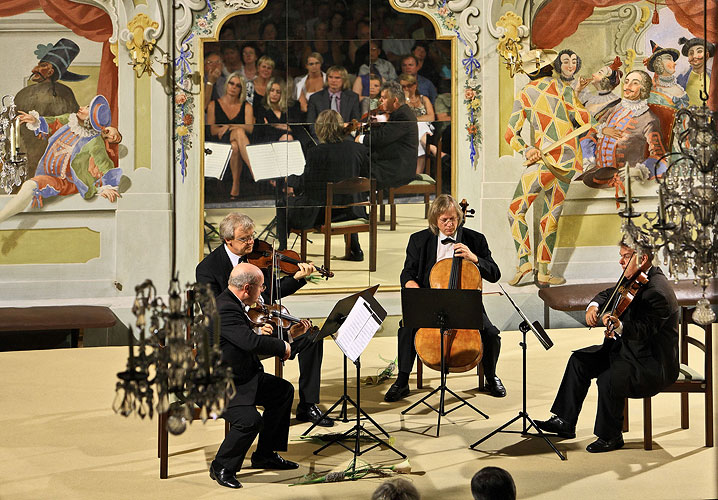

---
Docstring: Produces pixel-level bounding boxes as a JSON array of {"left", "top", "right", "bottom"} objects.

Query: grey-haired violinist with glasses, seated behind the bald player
[{"left": 195, "top": 213, "right": 334, "bottom": 427}]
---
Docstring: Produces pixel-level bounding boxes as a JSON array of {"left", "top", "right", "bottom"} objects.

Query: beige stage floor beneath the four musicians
[{"left": 0, "top": 330, "right": 718, "bottom": 500}]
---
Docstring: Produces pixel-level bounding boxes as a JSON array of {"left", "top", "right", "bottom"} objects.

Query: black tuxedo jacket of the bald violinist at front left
[{"left": 217, "top": 289, "right": 286, "bottom": 406}]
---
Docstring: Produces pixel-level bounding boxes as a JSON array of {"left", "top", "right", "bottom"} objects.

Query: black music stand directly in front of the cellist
[{"left": 401, "top": 288, "right": 489, "bottom": 437}]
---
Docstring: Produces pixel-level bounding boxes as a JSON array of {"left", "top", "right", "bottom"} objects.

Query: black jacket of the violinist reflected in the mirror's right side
[{"left": 362, "top": 102, "right": 419, "bottom": 188}]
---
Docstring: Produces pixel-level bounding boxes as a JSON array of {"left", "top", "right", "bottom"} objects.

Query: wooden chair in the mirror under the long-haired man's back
[{"left": 292, "top": 177, "right": 377, "bottom": 272}]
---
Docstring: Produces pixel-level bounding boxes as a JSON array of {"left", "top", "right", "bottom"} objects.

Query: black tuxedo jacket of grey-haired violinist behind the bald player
[{"left": 195, "top": 242, "right": 307, "bottom": 304}]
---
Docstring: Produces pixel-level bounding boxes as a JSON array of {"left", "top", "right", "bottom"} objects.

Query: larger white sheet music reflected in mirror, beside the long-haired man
[{"left": 247, "top": 141, "right": 304, "bottom": 181}]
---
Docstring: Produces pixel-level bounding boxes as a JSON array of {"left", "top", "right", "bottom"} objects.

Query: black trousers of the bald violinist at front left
[{"left": 214, "top": 372, "right": 294, "bottom": 472}]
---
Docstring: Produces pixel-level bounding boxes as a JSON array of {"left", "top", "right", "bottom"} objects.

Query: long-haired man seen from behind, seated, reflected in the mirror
[{"left": 277, "top": 109, "right": 369, "bottom": 261}]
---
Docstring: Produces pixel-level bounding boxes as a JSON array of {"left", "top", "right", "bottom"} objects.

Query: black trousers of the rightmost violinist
[{"left": 551, "top": 346, "right": 624, "bottom": 440}]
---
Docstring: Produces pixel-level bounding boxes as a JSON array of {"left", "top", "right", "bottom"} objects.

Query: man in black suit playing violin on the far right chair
[{"left": 536, "top": 240, "right": 680, "bottom": 453}]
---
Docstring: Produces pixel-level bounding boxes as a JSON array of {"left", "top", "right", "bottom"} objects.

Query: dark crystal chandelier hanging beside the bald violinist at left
[{"left": 112, "top": 277, "right": 235, "bottom": 434}]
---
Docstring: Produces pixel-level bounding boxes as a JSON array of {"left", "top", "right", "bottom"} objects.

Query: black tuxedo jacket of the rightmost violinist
[{"left": 582, "top": 266, "right": 680, "bottom": 398}]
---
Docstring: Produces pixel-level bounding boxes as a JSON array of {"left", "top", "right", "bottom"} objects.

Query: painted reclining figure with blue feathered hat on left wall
[{"left": 0, "top": 95, "right": 122, "bottom": 222}]
